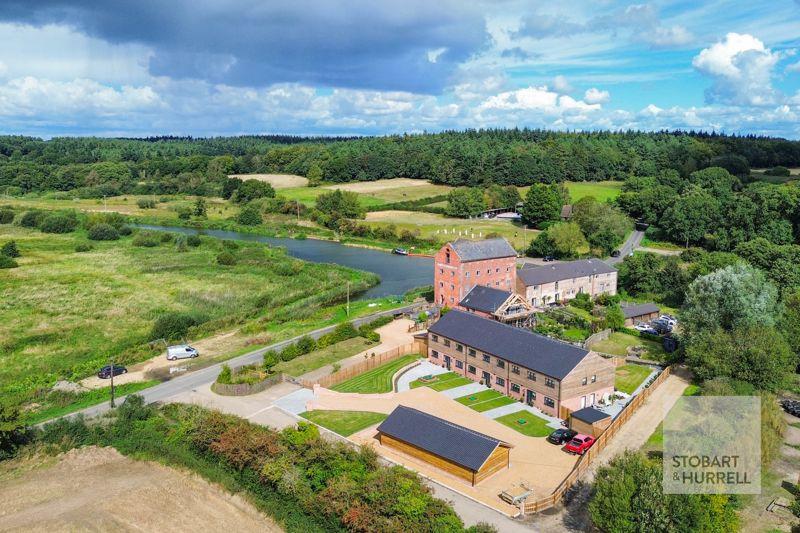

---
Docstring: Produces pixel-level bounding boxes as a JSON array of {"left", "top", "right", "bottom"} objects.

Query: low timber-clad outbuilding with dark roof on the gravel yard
[{"left": 378, "top": 405, "right": 512, "bottom": 486}]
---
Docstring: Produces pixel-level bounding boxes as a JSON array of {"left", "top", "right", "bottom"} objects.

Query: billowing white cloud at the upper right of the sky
[{"left": 692, "top": 33, "right": 781, "bottom": 106}]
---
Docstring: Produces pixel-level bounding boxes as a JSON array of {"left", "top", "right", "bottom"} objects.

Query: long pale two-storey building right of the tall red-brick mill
[{"left": 517, "top": 259, "right": 617, "bottom": 308}]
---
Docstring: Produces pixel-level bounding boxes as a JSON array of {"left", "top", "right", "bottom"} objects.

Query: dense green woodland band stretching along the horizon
[{"left": 0, "top": 129, "right": 800, "bottom": 197}]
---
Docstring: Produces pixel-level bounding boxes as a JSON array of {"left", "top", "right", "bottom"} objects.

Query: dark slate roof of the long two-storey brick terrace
[{"left": 428, "top": 310, "right": 589, "bottom": 379}]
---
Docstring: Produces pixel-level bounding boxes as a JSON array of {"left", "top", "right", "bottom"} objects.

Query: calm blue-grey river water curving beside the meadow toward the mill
[{"left": 136, "top": 224, "right": 433, "bottom": 299}]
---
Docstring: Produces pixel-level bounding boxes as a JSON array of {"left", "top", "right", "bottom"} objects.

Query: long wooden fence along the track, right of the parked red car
[{"left": 524, "top": 367, "right": 672, "bottom": 514}]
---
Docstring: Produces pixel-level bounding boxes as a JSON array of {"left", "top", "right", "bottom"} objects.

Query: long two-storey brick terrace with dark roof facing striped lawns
[{"left": 428, "top": 310, "right": 614, "bottom": 418}]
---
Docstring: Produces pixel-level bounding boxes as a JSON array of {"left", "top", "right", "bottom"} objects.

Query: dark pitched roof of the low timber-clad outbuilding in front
[{"left": 378, "top": 405, "right": 509, "bottom": 471}]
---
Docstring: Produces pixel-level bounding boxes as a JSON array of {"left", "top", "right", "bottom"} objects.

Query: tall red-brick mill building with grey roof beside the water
[{"left": 433, "top": 238, "right": 517, "bottom": 307}]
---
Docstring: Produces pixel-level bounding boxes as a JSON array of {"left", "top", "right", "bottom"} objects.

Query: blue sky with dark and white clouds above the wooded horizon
[{"left": 0, "top": 0, "right": 800, "bottom": 139}]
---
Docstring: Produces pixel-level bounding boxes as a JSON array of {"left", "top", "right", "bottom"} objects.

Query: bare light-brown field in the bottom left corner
[{"left": 0, "top": 447, "right": 282, "bottom": 533}]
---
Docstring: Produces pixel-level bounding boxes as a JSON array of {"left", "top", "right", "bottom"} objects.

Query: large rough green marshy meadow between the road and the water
[{"left": 0, "top": 225, "right": 374, "bottom": 403}]
